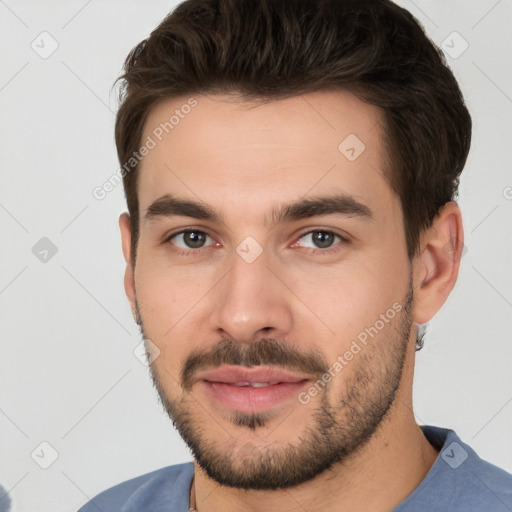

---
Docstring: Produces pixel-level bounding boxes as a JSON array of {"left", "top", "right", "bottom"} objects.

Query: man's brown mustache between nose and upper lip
[{"left": 180, "top": 339, "right": 329, "bottom": 391}]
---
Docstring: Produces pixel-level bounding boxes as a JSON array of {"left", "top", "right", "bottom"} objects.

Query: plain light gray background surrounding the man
[{"left": 0, "top": 0, "right": 512, "bottom": 512}]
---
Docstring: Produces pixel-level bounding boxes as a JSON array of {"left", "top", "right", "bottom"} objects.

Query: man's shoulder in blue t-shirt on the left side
[{"left": 78, "top": 462, "right": 194, "bottom": 512}]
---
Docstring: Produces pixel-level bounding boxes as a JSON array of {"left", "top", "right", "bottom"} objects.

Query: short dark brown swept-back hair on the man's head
[{"left": 115, "top": 0, "right": 471, "bottom": 262}]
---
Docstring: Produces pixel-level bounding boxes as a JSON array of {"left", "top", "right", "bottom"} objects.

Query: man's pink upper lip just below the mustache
[{"left": 197, "top": 366, "right": 310, "bottom": 384}]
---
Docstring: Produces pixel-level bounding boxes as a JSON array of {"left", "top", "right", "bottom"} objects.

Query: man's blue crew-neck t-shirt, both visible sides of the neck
[{"left": 78, "top": 426, "right": 512, "bottom": 512}]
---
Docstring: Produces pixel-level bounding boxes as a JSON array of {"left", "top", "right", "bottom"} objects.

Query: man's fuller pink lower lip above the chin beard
[{"left": 198, "top": 380, "right": 309, "bottom": 412}]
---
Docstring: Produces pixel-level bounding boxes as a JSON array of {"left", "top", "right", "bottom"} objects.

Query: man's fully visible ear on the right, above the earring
[{"left": 413, "top": 202, "right": 464, "bottom": 324}]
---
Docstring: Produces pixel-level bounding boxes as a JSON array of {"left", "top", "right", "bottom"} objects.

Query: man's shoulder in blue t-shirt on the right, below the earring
[{"left": 395, "top": 427, "right": 512, "bottom": 512}]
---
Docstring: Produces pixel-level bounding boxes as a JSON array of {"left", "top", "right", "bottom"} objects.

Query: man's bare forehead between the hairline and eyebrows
[{"left": 138, "top": 91, "right": 397, "bottom": 224}]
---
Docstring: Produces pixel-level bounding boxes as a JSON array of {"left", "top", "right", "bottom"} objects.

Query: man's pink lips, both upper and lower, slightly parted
[{"left": 197, "top": 366, "right": 311, "bottom": 413}]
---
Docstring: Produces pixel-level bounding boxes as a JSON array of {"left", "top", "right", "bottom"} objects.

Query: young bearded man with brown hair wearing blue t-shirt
[{"left": 77, "top": 0, "right": 512, "bottom": 512}]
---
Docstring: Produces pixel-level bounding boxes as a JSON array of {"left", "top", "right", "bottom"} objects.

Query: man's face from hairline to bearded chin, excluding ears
[{"left": 123, "top": 91, "right": 414, "bottom": 489}]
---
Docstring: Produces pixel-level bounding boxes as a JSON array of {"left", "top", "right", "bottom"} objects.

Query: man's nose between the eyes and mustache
[{"left": 210, "top": 246, "right": 293, "bottom": 342}]
